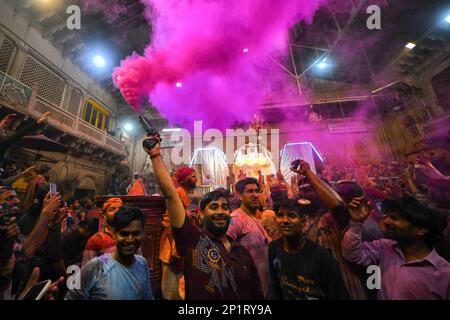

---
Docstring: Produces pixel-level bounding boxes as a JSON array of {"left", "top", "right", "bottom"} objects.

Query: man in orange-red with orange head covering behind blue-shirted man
[{"left": 81, "top": 198, "right": 123, "bottom": 266}]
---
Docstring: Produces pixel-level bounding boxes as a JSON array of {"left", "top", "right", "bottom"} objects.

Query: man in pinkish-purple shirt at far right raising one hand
[{"left": 342, "top": 197, "right": 450, "bottom": 300}]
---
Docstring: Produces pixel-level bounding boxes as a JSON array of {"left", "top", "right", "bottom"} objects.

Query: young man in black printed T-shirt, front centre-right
[{"left": 269, "top": 199, "right": 349, "bottom": 300}]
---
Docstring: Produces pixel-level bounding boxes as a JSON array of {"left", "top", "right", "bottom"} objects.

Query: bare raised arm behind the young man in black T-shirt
[{"left": 291, "top": 160, "right": 346, "bottom": 210}]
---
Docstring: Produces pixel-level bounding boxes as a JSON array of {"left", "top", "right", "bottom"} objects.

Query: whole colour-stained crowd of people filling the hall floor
[{"left": 0, "top": 114, "right": 450, "bottom": 300}]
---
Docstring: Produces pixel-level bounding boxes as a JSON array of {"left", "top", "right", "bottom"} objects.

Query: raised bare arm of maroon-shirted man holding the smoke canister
[{"left": 142, "top": 136, "right": 186, "bottom": 228}]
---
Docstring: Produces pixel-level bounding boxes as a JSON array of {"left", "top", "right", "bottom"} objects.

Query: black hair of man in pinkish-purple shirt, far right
[{"left": 383, "top": 197, "right": 448, "bottom": 249}]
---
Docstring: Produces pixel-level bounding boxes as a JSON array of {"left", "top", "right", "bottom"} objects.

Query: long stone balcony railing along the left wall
[{"left": 0, "top": 72, "right": 126, "bottom": 156}]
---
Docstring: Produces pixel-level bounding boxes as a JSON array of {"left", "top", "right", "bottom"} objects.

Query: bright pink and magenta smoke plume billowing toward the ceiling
[{"left": 113, "top": 0, "right": 324, "bottom": 129}]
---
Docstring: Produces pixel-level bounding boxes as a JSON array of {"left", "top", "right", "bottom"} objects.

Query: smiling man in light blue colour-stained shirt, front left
[{"left": 66, "top": 206, "right": 154, "bottom": 300}]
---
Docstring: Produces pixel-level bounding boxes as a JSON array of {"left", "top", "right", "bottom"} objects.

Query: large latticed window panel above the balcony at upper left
[{"left": 20, "top": 56, "right": 66, "bottom": 107}]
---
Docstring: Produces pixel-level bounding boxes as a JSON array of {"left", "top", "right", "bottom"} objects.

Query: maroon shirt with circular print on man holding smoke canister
[{"left": 172, "top": 219, "right": 263, "bottom": 300}]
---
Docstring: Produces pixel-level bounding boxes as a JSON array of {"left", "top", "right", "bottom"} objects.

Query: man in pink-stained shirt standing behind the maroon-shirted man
[{"left": 227, "top": 178, "right": 270, "bottom": 297}]
